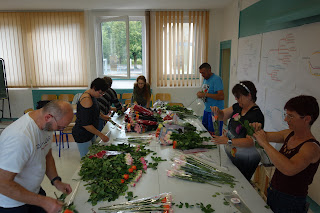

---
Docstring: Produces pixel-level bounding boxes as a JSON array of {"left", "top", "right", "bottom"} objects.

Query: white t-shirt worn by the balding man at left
[{"left": 0, "top": 114, "right": 52, "bottom": 208}]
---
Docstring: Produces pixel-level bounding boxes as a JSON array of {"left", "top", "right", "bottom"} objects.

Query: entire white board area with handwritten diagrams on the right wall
[{"left": 237, "top": 22, "right": 320, "bottom": 134}]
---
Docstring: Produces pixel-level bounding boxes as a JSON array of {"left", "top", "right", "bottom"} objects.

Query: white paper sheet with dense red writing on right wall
[{"left": 259, "top": 28, "right": 300, "bottom": 91}]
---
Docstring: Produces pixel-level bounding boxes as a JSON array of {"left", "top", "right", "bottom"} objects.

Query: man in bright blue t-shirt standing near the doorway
[{"left": 197, "top": 63, "right": 224, "bottom": 133}]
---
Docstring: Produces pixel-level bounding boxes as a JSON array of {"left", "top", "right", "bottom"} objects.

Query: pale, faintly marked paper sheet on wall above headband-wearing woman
[{"left": 237, "top": 34, "right": 261, "bottom": 83}]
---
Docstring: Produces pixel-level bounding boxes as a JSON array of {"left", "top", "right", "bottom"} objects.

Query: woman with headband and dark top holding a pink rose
[{"left": 211, "top": 81, "right": 264, "bottom": 182}]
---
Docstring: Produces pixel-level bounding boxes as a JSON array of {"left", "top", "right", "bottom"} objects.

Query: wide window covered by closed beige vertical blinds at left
[{"left": 0, "top": 12, "right": 88, "bottom": 87}]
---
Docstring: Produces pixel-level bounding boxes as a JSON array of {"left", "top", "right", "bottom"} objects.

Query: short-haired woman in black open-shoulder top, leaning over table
[{"left": 72, "top": 78, "right": 110, "bottom": 158}]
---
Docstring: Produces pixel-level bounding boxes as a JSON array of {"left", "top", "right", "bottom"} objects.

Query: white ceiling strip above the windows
[{"left": 0, "top": 0, "right": 233, "bottom": 11}]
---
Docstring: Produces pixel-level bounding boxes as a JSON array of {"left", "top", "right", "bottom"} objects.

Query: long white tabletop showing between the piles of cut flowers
[{"left": 73, "top": 115, "right": 272, "bottom": 213}]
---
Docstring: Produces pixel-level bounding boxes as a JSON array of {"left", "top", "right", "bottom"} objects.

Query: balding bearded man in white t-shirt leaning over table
[{"left": 0, "top": 100, "right": 73, "bottom": 213}]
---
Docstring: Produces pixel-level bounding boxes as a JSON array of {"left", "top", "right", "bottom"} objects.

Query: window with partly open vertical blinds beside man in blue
[{"left": 151, "top": 11, "right": 209, "bottom": 87}]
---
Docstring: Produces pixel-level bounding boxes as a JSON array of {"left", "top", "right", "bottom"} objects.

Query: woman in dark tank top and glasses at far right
[{"left": 253, "top": 95, "right": 320, "bottom": 213}]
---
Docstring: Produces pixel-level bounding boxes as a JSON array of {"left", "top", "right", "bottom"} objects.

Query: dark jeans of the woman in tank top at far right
[{"left": 267, "top": 186, "right": 308, "bottom": 213}]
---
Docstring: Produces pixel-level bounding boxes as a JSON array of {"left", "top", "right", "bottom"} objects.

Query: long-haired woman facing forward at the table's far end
[{"left": 132, "top": 75, "right": 151, "bottom": 108}]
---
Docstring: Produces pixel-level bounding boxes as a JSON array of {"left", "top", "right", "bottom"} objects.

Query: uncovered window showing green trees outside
[{"left": 97, "top": 16, "right": 145, "bottom": 79}]
